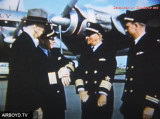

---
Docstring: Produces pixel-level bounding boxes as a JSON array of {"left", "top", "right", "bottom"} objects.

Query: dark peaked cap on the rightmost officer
[{"left": 124, "top": 10, "right": 147, "bottom": 24}]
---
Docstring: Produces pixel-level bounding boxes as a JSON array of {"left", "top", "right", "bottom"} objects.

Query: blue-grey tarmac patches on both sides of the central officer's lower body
[{"left": 65, "top": 83, "right": 124, "bottom": 119}]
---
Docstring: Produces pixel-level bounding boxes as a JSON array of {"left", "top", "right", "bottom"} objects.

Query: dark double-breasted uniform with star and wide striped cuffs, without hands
[{"left": 74, "top": 43, "right": 116, "bottom": 119}]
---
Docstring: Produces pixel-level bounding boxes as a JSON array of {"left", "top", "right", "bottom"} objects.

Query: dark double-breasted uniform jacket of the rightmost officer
[{"left": 121, "top": 34, "right": 160, "bottom": 115}]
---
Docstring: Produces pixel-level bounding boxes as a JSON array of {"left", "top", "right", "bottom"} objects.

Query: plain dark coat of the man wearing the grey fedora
[{"left": 6, "top": 32, "right": 39, "bottom": 112}]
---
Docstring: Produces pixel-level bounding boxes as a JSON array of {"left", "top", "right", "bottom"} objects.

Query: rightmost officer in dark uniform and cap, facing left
[{"left": 120, "top": 11, "right": 160, "bottom": 119}]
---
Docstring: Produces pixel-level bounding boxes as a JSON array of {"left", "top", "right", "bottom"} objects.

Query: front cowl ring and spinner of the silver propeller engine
[{"left": 51, "top": 8, "right": 87, "bottom": 36}]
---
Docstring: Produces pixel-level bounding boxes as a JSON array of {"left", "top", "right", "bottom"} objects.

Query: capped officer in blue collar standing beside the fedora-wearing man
[{"left": 36, "top": 25, "right": 74, "bottom": 119}]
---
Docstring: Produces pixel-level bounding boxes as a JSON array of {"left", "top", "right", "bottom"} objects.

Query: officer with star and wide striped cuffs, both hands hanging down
[{"left": 74, "top": 22, "right": 116, "bottom": 119}]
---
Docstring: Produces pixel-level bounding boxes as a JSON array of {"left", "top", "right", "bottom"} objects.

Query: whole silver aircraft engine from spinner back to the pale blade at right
[{"left": 51, "top": 7, "right": 125, "bottom": 36}]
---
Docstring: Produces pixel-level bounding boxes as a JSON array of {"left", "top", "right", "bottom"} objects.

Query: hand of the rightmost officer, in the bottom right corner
[{"left": 143, "top": 107, "right": 154, "bottom": 119}]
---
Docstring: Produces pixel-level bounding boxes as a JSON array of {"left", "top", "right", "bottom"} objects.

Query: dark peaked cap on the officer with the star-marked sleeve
[{"left": 86, "top": 22, "right": 105, "bottom": 36}]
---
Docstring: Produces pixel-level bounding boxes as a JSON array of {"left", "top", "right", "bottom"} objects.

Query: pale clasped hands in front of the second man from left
[{"left": 58, "top": 67, "right": 71, "bottom": 86}]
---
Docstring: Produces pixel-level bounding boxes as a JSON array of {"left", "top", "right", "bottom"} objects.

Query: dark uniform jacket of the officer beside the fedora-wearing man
[{"left": 36, "top": 47, "right": 73, "bottom": 118}]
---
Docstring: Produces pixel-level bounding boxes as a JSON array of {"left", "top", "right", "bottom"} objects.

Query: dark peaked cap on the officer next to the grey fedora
[{"left": 41, "top": 24, "right": 57, "bottom": 40}]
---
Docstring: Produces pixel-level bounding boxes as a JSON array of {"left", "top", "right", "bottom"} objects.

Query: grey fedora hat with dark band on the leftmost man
[{"left": 26, "top": 8, "right": 48, "bottom": 23}]
